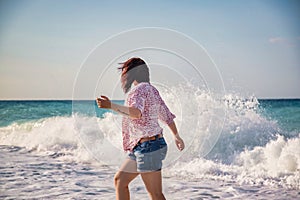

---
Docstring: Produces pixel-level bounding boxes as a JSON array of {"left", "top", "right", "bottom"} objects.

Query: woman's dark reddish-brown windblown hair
[{"left": 118, "top": 58, "right": 150, "bottom": 93}]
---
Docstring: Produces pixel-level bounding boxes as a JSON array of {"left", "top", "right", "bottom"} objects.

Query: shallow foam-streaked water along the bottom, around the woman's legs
[{"left": 0, "top": 146, "right": 300, "bottom": 200}]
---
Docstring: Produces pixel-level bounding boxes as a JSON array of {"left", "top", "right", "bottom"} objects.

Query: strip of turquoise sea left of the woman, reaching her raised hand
[{"left": 0, "top": 100, "right": 123, "bottom": 127}]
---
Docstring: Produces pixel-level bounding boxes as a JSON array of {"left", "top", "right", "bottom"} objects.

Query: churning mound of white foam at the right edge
[{"left": 236, "top": 135, "right": 300, "bottom": 189}]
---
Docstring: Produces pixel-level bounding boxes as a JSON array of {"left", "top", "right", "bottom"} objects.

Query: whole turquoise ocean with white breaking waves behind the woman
[{"left": 0, "top": 87, "right": 300, "bottom": 199}]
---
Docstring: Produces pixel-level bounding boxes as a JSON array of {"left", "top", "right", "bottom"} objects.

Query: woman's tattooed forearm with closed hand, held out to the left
[{"left": 96, "top": 96, "right": 142, "bottom": 119}]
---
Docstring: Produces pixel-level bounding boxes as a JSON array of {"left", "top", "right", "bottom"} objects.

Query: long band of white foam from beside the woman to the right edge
[{"left": 165, "top": 136, "right": 300, "bottom": 189}]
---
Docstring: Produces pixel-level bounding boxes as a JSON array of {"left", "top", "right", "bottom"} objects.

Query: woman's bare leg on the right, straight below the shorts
[{"left": 141, "top": 171, "right": 166, "bottom": 200}]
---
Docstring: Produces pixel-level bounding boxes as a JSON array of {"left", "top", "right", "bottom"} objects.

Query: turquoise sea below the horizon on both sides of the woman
[{"left": 0, "top": 99, "right": 300, "bottom": 133}]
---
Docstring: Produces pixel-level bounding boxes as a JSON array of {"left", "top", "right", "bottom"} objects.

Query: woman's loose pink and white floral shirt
[{"left": 122, "top": 82, "right": 175, "bottom": 151}]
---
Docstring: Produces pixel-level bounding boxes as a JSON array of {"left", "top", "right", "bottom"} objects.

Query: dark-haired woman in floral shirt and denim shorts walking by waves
[{"left": 96, "top": 58, "right": 184, "bottom": 200}]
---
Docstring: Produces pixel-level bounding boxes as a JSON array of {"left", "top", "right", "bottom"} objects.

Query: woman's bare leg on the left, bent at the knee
[{"left": 114, "top": 159, "right": 139, "bottom": 200}]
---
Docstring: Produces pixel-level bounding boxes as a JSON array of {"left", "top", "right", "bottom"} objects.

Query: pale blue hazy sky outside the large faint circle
[{"left": 0, "top": 0, "right": 300, "bottom": 99}]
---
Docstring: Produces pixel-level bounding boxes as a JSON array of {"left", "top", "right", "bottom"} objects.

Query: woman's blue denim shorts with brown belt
[{"left": 128, "top": 137, "right": 168, "bottom": 172}]
